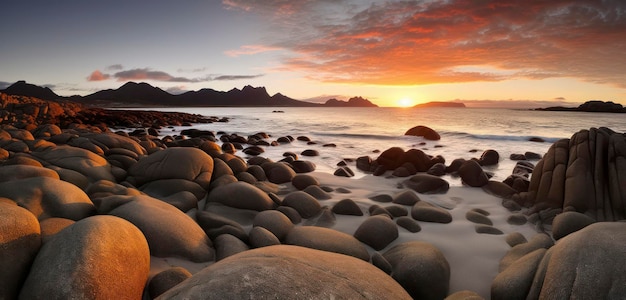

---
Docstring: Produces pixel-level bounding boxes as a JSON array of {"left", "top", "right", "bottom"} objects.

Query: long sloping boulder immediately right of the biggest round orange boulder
[{"left": 107, "top": 195, "right": 215, "bottom": 262}]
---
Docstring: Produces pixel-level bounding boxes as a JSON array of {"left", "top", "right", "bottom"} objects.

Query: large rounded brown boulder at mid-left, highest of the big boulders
[{"left": 128, "top": 147, "right": 213, "bottom": 189}]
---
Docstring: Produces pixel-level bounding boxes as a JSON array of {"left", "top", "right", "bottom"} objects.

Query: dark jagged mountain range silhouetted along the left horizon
[{"left": 0, "top": 81, "right": 377, "bottom": 107}]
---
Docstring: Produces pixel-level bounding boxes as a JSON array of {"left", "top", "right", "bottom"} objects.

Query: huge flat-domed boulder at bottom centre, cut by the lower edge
[{"left": 156, "top": 245, "right": 411, "bottom": 299}]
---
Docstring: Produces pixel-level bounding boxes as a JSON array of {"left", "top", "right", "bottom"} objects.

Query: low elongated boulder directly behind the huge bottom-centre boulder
[{"left": 285, "top": 226, "right": 370, "bottom": 261}]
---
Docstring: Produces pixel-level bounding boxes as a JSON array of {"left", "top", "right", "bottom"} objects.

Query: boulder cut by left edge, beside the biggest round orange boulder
[{"left": 0, "top": 200, "right": 41, "bottom": 299}]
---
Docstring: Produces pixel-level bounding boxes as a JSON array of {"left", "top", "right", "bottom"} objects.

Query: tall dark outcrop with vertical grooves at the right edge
[{"left": 518, "top": 128, "right": 626, "bottom": 221}]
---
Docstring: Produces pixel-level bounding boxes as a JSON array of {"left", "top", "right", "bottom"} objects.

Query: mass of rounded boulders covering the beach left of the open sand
[{"left": 0, "top": 111, "right": 450, "bottom": 299}]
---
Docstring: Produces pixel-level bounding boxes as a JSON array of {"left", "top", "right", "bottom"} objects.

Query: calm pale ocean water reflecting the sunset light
[{"left": 134, "top": 107, "right": 626, "bottom": 186}]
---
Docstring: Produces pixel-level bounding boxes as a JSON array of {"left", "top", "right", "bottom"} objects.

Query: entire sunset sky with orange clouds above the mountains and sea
[{"left": 0, "top": 0, "right": 626, "bottom": 107}]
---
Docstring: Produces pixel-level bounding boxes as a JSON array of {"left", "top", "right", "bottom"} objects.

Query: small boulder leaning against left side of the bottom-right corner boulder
[{"left": 491, "top": 249, "right": 547, "bottom": 299}]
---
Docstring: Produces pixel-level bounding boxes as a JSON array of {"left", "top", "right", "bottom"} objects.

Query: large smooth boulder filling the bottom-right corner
[{"left": 528, "top": 222, "right": 626, "bottom": 299}]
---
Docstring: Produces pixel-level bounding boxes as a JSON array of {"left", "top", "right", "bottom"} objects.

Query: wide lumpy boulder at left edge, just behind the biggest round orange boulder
[{"left": 0, "top": 177, "right": 96, "bottom": 221}]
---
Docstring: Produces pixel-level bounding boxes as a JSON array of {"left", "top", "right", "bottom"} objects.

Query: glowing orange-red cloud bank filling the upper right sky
[{"left": 222, "top": 0, "right": 626, "bottom": 87}]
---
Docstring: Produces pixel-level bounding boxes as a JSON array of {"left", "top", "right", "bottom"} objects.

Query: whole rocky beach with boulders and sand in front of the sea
[{"left": 0, "top": 93, "right": 626, "bottom": 299}]
